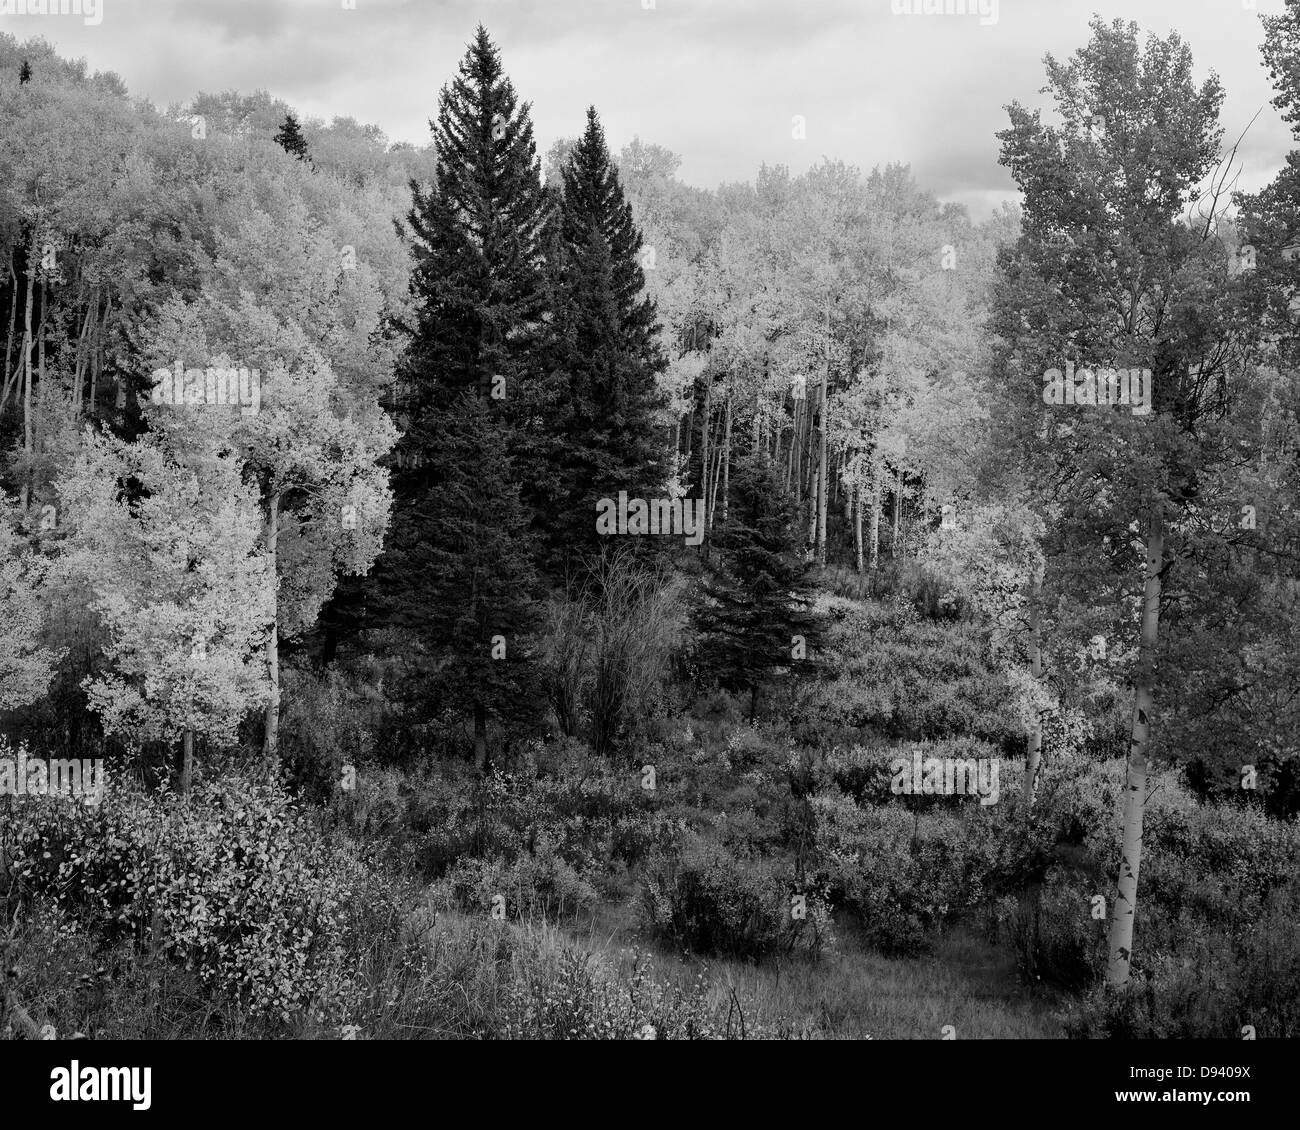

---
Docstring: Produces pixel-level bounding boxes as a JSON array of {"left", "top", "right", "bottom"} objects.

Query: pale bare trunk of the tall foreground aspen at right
[{"left": 1106, "top": 503, "right": 1165, "bottom": 988}]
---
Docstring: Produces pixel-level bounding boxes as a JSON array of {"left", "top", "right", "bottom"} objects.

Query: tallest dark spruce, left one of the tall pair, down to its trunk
[{"left": 368, "top": 26, "right": 546, "bottom": 769}]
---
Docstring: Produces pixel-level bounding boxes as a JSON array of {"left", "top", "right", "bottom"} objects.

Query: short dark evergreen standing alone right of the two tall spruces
[{"left": 699, "top": 454, "right": 818, "bottom": 718}]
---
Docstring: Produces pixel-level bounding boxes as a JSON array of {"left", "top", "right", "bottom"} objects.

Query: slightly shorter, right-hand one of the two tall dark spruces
[{"left": 546, "top": 108, "right": 667, "bottom": 570}]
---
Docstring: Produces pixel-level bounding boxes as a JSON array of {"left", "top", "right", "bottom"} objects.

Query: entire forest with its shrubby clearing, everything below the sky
[{"left": 0, "top": 8, "right": 1300, "bottom": 1039}]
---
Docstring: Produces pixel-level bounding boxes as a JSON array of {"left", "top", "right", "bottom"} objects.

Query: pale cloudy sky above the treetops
[{"left": 0, "top": 0, "right": 1295, "bottom": 217}]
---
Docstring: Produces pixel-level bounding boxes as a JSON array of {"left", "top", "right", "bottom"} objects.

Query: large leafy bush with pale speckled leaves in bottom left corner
[{"left": 0, "top": 776, "right": 371, "bottom": 1021}]
